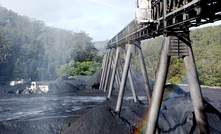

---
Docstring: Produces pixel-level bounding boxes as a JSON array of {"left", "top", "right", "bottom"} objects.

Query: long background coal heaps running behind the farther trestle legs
[{"left": 46, "top": 69, "right": 154, "bottom": 95}]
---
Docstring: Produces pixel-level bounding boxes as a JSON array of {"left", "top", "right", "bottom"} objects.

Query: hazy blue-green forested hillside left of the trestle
[{"left": 0, "top": 6, "right": 102, "bottom": 83}]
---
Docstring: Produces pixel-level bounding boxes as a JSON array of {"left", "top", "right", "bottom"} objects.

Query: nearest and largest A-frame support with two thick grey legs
[{"left": 145, "top": 31, "right": 209, "bottom": 134}]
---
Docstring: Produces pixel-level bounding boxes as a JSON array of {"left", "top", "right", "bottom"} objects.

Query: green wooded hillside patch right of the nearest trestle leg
[{"left": 190, "top": 26, "right": 221, "bottom": 86}]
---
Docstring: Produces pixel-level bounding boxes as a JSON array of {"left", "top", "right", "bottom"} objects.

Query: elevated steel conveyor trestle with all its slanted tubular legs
[{"left": 99, "top": 0, "right": 221, "bottom": 134}]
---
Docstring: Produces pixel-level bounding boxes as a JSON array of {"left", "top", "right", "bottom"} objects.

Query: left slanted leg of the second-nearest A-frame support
[{"left": 115, "top": 44, "right": 132, "bottom": 113}]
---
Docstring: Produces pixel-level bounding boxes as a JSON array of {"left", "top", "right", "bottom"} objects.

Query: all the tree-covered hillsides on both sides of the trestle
[{"left": 0, "top": 6, "right": 221, "bottom": 86}]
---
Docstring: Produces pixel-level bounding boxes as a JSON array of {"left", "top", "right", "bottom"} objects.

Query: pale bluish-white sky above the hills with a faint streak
[{"left": 0, "top": 0, "right": 221, "bottom": 41}]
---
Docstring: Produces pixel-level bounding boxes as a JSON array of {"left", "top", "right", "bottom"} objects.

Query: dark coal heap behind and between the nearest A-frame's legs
[{"left": 158, "top": 84, "right": 221, "bottom": 134}]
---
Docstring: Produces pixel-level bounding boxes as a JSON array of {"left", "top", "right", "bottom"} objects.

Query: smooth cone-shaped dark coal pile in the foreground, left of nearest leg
[{"left": 63, "top": 105, "right": 131, "bottom": 134}]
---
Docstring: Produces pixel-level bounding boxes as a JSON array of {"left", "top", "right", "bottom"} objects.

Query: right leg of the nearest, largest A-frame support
[{"left": 183, "top": 36, "right": 210, "bottom": 134}]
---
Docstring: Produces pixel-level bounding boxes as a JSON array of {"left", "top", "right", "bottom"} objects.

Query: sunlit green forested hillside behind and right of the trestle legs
[{"left": 132, "top": 26, "right": 221, "bottom": 86}]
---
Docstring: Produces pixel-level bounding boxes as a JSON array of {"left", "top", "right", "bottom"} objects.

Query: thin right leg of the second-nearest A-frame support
[{"left": 138, "top": 43, "right": 151, "bottom": 104}]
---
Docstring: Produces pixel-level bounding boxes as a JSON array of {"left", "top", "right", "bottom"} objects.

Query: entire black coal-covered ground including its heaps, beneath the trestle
[{"left": 0, "top": 70, "right": 221, "bottom": 134}]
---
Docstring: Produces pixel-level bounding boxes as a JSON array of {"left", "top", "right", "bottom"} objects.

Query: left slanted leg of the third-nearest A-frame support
[{"left": 107, "top": 47, "right": 120, "bottom": 98}]
